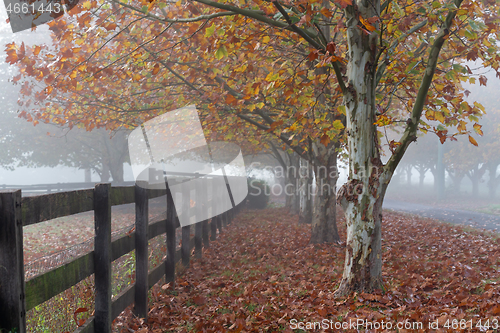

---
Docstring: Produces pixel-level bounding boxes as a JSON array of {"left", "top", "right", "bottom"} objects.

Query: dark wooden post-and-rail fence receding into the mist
[{"left": 0, "top": 175, "right": 241, "bottom": 333}]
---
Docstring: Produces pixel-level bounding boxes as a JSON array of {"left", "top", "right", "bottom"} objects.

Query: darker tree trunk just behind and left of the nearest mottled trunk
[{"left": 310, "top": 150, "right": 340, "bottom": 244}]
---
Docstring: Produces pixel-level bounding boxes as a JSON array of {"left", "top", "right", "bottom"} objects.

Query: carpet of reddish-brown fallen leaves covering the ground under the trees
[{"left": 115, "top": 208, "right": 500, "bottom": 333}]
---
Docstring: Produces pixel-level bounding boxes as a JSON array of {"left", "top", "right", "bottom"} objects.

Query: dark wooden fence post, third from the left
[{"left": 134, "top": 182, "right": 149, "bottom": 320}]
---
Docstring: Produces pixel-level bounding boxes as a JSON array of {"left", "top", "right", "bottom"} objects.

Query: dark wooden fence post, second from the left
[{"left": 94, "top": 183, "right": 112, "bottom": 333}]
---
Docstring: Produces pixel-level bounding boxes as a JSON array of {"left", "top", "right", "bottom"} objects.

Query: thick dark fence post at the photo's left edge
[{"left": 0, "top": 190, "right": 26, "bottom": 333}]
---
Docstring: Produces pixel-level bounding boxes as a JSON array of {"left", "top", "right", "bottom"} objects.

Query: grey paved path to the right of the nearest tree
[{"left": 383, "top": 199, "right": 500, "bottom": 232}]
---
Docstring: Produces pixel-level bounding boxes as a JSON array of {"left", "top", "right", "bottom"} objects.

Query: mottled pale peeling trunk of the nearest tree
[{"left": 335, "top": 1, "right": 384, "bottom": 296}]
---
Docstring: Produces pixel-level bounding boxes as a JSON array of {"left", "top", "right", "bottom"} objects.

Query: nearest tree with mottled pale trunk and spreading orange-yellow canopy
[{"left": 8, "top": 0, "right": 500, "bottom": 295}]
